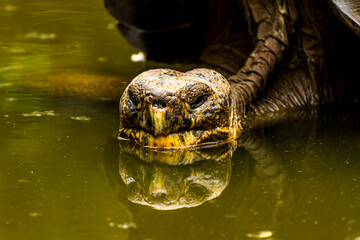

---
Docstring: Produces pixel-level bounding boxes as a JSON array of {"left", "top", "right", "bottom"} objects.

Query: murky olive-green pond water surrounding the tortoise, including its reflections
[{"left": 0, "top": 0, "right": 360, "bottom": 240}]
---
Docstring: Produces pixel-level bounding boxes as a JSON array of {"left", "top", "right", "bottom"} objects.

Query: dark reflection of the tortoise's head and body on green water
[{"left": 104, "top": 108, "right": 360, "bottom": 239}]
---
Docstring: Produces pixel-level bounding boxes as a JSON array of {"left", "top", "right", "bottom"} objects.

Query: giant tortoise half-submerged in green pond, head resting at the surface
[{"left": 105, "top": 0, "right": 360, "bottom": 148}]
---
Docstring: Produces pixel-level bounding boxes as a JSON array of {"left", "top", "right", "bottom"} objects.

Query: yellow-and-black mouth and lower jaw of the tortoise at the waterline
[{"left": 118, "top": 127, "right": 230, "bottom": 149}]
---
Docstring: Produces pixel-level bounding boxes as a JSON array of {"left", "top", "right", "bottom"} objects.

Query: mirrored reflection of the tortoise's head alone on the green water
[{"left": 119, "top": 141, "right": 235, "bottom": 210}]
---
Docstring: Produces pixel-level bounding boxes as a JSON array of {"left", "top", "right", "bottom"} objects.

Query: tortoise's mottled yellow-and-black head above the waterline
[{"left": 119, "top": 68, "right": 241, "bottom": 148}]
